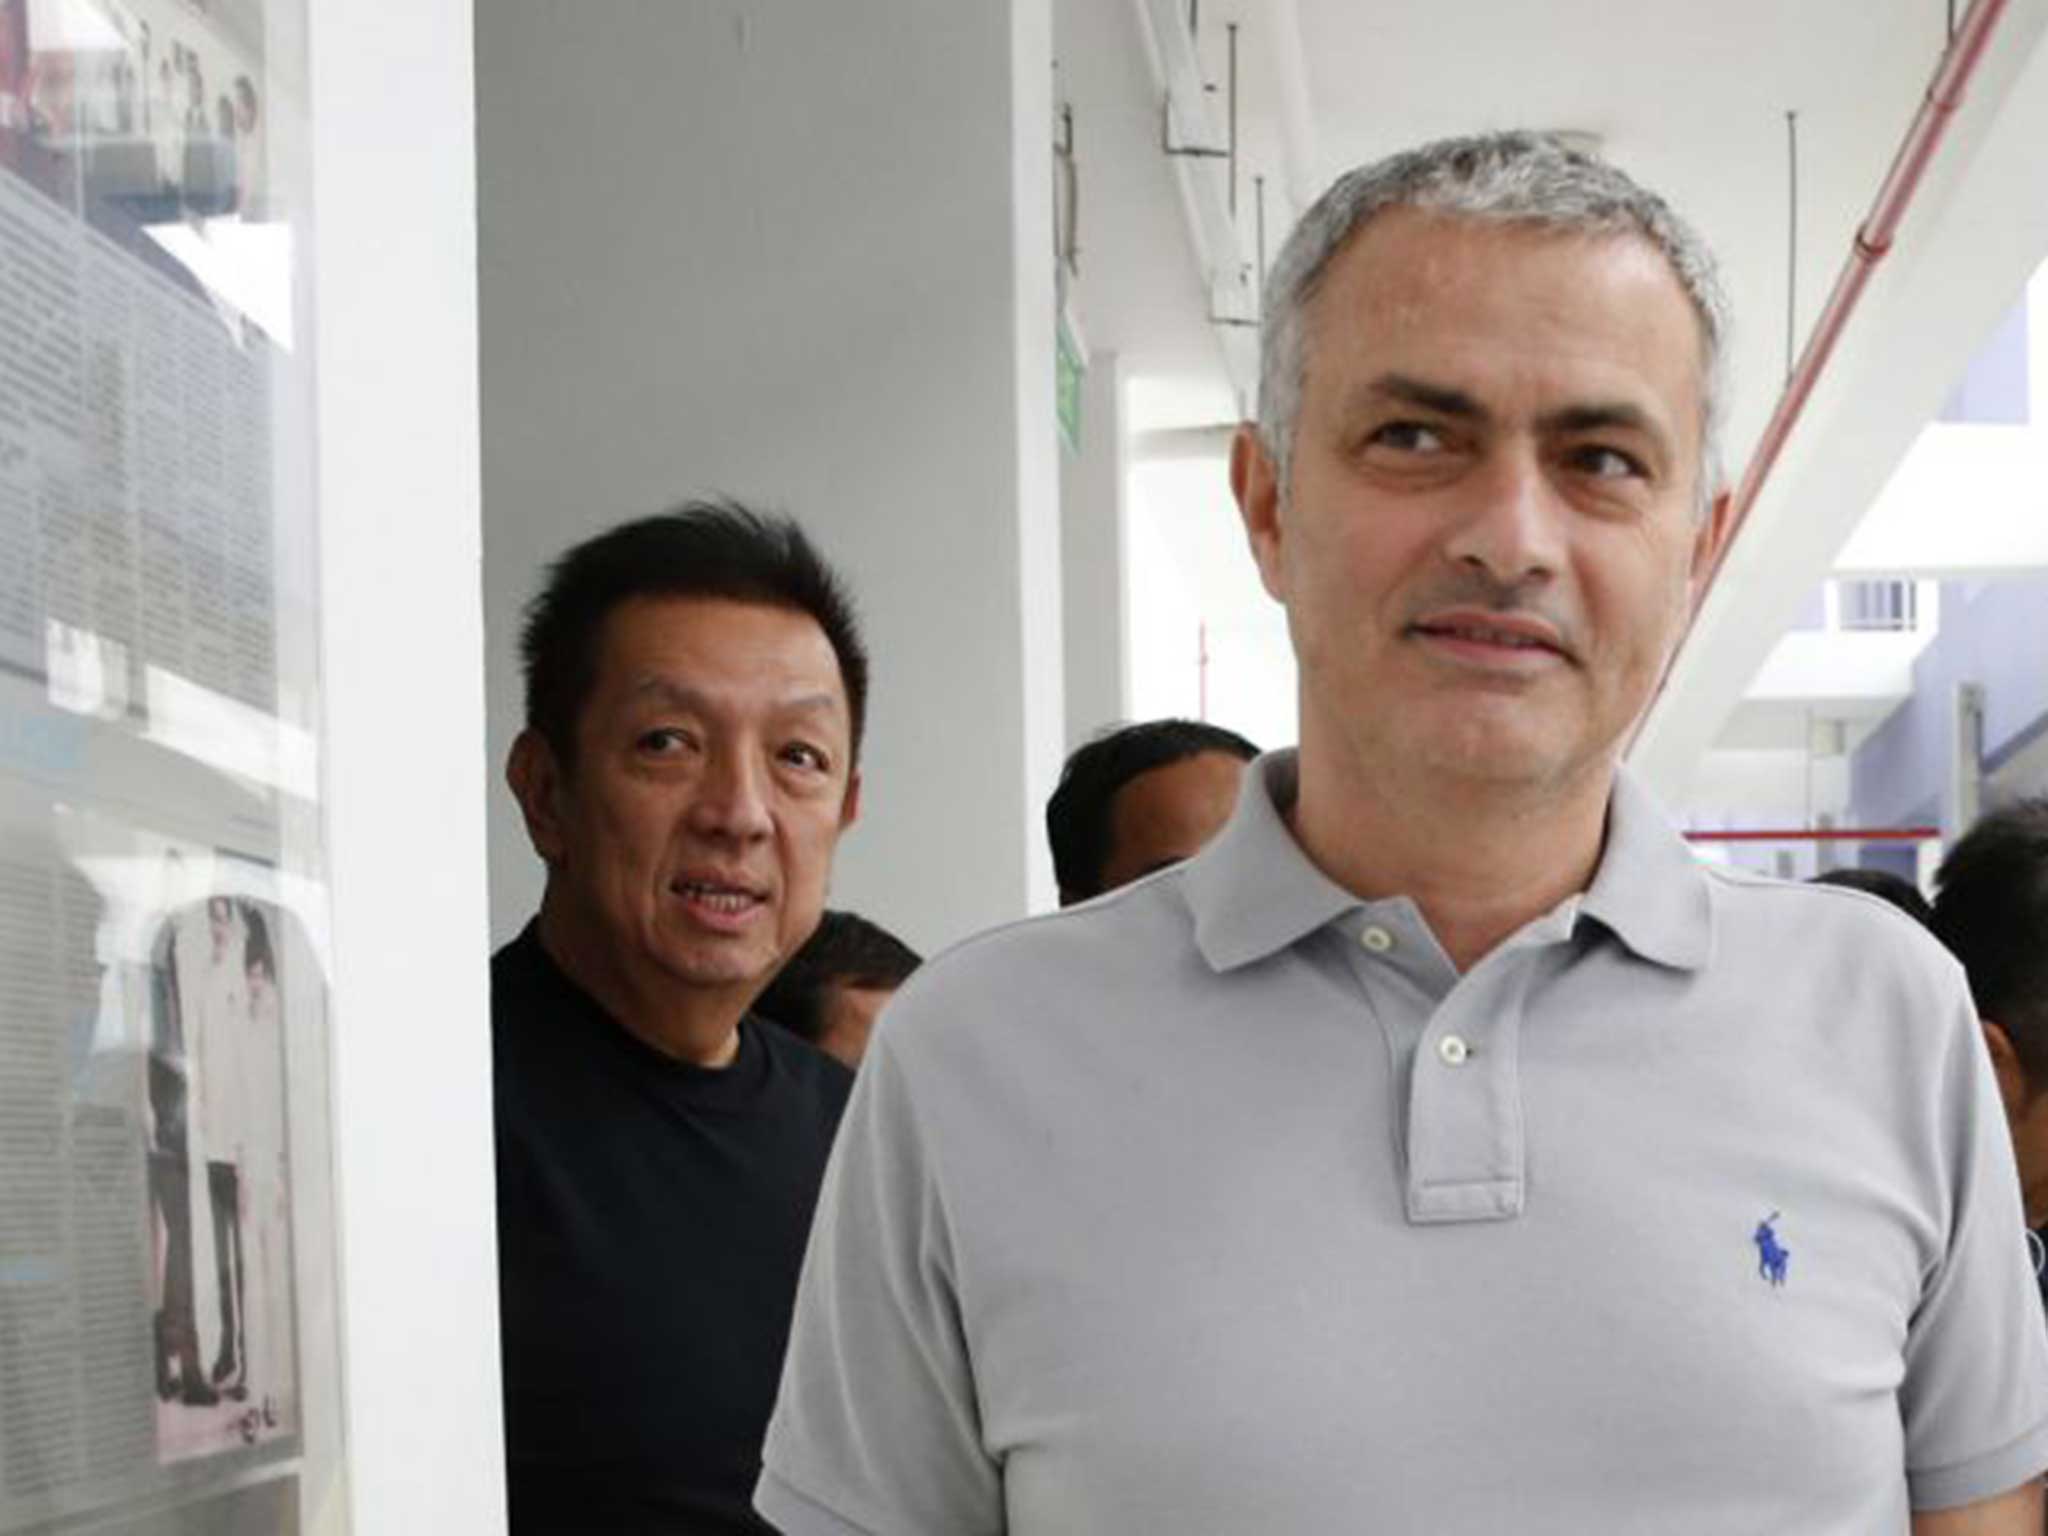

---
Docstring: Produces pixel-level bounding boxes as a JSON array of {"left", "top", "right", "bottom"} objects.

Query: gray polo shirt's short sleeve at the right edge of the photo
[{"left": 1901, "top": 987, "right": 2048, "bottom": 1509}]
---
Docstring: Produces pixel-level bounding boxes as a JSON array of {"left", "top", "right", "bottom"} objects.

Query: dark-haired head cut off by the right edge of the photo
[{"left": 1933, "top": 795, "right": 2048, "bottom": 1227}]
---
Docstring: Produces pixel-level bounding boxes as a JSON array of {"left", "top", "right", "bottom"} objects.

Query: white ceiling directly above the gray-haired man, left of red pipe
[{"left": 1296, "top": 0, "right": 1948, "bottom": 475}]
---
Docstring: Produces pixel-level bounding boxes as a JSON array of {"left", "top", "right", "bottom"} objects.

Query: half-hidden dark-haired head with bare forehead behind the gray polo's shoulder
[{"left": 1044, "top": 719, "right": 1260, "bottom": 907}]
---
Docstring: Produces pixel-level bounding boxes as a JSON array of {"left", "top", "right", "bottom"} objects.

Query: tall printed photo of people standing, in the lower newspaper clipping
[{"left": 147, "top": 895, "right": 299, "bottom": 1462}]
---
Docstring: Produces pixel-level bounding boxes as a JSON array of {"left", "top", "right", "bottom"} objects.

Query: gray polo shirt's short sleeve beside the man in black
[{"left": 754, "top": 1024, "right": 1004, "bottom": 1536}]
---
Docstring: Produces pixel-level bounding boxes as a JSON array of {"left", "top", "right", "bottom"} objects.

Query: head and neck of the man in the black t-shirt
[{"left": 508, "top": 502, "right": 868, "bottom": 1065}]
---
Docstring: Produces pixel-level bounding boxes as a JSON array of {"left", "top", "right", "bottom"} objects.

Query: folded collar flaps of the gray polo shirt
[{"left": 1182, "top": 748, "right": 1714, "bottom": 971}]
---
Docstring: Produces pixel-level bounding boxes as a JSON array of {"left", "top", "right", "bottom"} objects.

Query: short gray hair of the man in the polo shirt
[{"left": 1260, "top": 133, "right": 1729, "bottom": 508}]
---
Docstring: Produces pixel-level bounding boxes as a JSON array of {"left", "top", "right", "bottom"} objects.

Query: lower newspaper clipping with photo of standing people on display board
[{"left": 0, "top": 819, "right": 311, "bottom": 1536}]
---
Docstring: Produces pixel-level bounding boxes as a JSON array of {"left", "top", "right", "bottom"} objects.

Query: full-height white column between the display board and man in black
[{"left": 307, "top": 0, "right": 504, "bottom": 1536}]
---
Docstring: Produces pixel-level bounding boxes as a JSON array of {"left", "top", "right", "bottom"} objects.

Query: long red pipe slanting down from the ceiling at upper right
[{"left": 1696, "top": 0, "right": 2007, "bottom": 612}]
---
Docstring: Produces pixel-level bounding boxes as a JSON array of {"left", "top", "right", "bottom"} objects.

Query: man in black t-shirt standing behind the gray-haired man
[{"left": 505, "top": 504, "right": 866, "bottom": 1534}]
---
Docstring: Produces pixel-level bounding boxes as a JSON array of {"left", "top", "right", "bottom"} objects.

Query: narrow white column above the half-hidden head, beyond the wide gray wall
[{"left": 1059, "top": 352, "right": 1130, "bottom": 752}]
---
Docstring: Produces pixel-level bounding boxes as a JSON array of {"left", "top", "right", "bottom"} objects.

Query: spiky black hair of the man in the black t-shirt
[{"left": 520, "top": 500, "right": 868, "bottom": 768}]
